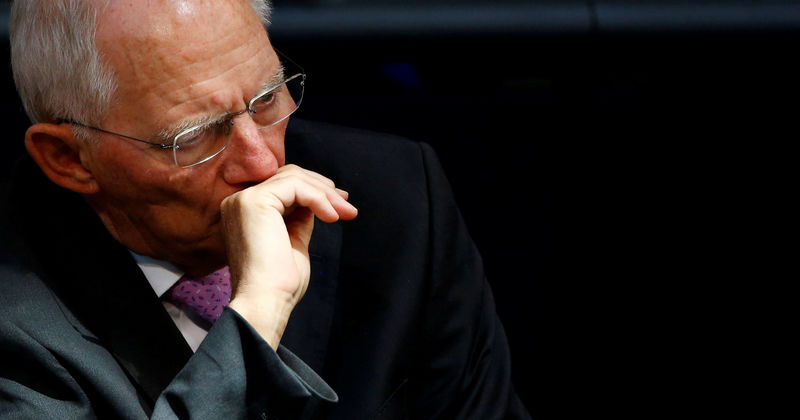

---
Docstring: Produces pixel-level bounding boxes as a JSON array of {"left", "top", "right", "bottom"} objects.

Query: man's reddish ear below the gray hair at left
[{"left": 25, "top": 123, "right": 99, "bottom": 194}]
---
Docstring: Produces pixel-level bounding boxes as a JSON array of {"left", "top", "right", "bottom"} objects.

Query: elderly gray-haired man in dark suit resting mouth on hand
[{"left": 0, "top": 0, "right": 527, "bottom": 419}]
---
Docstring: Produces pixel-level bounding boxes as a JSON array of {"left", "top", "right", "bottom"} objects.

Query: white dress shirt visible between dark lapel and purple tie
[{"left": 131, "top": 252, "right": 208, "bottom": 351}]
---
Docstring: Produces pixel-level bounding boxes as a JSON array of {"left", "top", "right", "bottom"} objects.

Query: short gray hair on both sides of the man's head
[{"left": 9, "top": 0, "right": 271, "bottom": 137}]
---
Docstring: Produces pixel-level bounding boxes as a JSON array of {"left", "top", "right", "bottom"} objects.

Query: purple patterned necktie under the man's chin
[{"left": 164, "top": 266, "right": 231, "bottom": 324}]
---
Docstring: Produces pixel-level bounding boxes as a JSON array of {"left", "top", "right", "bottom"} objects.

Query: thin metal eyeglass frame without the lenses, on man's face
[{"left": 62, "top": 50, "right": 306, "bottom": 169}]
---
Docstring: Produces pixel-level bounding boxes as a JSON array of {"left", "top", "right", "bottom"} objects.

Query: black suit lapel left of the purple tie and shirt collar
[{"left": 15, "top": 158, "right": 192, "bottom": 409}]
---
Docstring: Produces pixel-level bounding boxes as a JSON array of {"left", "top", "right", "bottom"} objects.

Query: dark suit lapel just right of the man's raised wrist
[{"left": 281, "top": 220, "right": 342, "bottom": 373}]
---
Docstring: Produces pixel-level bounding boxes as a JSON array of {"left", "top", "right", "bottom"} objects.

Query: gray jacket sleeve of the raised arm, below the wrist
[{"left": 153, "top": 308, "right": 338, "bottom": 419}]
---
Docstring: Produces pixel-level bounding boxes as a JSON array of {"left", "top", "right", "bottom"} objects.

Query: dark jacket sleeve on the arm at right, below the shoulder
[{"left": 410, "top": 144, "right": 530, "bottom": 419}]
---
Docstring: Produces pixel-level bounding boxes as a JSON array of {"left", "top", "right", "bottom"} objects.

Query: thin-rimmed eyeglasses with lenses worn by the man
[{"left": 67, "top": 53, "right": 306, "bottom": 168}]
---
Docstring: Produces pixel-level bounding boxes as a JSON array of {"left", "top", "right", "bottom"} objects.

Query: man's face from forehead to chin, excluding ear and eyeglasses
[{"left": 82, "top": 0, "right": 287, "bottom": 271}]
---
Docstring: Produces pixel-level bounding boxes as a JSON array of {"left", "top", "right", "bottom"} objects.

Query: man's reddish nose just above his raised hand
[{"left": 222, "top": 113, "right": 284, "bottom": 185}]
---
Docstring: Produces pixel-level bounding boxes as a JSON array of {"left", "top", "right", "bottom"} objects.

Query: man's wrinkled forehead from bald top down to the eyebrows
[{"left": 97, "top": 0, "right": 272, "bottom": 125}]
